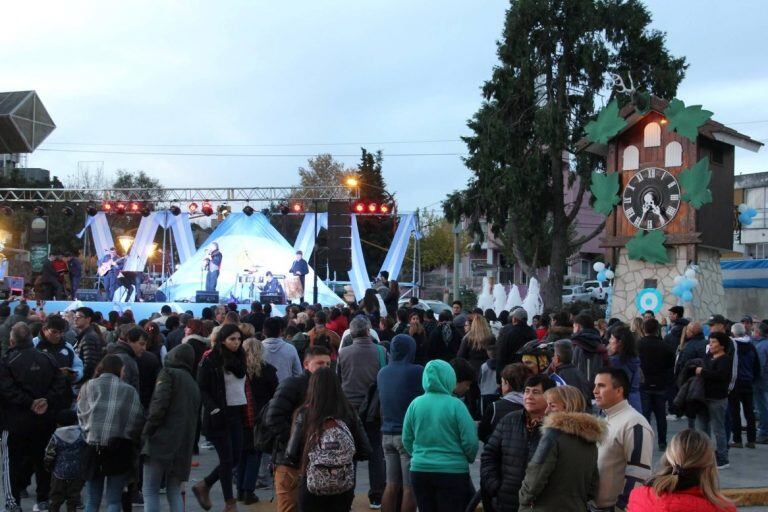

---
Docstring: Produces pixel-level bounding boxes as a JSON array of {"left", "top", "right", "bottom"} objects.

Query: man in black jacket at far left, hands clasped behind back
[{"left": 0, "top": 323, "right": 67, "bottom": 510}]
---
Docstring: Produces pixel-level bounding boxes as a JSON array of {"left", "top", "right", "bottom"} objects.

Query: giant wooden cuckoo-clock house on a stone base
[{"left": 583, "top": 96, "right": 762, "bottom": 320}]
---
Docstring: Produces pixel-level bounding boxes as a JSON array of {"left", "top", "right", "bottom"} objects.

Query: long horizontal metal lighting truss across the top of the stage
[{"left": 0, "top": 187, "right": 359, "bottom": 203}]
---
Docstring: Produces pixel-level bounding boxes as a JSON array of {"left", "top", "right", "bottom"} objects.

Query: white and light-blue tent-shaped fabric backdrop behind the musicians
[{"left": 160, "top": 213, "right": 341, "bottom": 305}]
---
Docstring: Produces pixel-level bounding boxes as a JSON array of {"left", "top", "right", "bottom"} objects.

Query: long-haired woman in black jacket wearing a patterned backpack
[{"left": 285, "top": 368, "right": 371, "bottom": 512}]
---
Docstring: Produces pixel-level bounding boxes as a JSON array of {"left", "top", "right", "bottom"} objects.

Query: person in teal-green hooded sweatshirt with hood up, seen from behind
[{"left": 402, "top": 359, "right": 478, "bottom": 512}]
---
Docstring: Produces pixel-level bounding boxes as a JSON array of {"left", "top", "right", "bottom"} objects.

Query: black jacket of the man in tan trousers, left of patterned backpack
[{"left": 264, "top": 371, "right": 311, "bottom": 466}]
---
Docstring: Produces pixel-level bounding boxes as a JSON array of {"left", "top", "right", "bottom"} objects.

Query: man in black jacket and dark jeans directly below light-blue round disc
[{"left": 639, "top": 316, "right": 677, "bottom": 451}]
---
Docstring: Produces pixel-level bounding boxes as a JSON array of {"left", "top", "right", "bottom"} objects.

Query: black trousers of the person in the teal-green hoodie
[{"left": 411, "top": 471, "right": 473, "bottom": 512}]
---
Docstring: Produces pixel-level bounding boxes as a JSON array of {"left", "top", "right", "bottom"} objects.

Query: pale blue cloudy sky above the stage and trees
[{"left": 0, "top": 0, "right": 768, "bottom": 211}]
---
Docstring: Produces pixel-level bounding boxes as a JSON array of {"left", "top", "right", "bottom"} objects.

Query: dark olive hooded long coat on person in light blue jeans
[{"left": 141, "top": 344, "right": 200, "bottom": 481}]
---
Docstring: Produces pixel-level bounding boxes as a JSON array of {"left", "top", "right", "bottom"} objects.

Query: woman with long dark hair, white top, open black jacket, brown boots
[{"left": 192, "top": 324, "right": 248, "bottom": 512}]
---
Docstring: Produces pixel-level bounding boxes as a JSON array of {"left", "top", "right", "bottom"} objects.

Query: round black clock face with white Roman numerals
[{"left": 621, "top": 167, "right": 680, "bottom": 231}]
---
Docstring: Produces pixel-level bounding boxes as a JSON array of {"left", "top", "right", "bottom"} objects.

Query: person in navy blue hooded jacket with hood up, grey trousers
[{"left": 377, "top": 334, "right": 424, "bottom": 512}]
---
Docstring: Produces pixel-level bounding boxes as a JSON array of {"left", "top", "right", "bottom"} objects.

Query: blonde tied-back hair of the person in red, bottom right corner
[{"left": 651, "top": 429, "right": 732, "bottom": 508}]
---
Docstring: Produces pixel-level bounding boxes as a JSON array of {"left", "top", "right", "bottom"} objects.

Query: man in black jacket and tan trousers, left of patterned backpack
[{"left": 264, "top": 346, "right": 331, "bottom": 512}]
